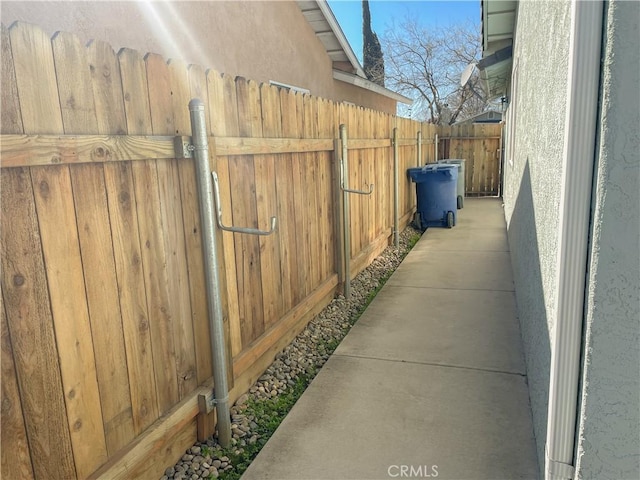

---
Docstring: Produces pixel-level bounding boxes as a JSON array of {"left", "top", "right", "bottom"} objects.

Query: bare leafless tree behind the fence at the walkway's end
[{"left": 383, "top": 18, "right": 487, "bottom": 124}]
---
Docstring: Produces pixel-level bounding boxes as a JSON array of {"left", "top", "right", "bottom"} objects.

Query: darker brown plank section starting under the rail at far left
[{"left": 0, "top": 168, "right": 76, "bottom": 478}]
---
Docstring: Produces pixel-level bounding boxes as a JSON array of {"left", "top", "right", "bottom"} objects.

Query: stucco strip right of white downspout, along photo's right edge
[{"left": 577, "top": 1, "right": 640, "bottom": 479}]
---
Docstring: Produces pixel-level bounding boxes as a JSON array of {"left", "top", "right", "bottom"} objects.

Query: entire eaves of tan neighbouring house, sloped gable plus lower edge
[{"left": 297, "top": 0, "right": 413, "bottom": 105}]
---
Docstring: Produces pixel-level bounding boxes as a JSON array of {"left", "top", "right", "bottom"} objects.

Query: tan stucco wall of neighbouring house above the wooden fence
[{"left": 0, "top": 0, "right": 396, "bottom": 113}]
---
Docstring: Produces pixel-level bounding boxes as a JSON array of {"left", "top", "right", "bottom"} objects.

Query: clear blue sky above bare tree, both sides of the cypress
[{"left": 327, "top": 0, "right": 480, "bottom": 63}]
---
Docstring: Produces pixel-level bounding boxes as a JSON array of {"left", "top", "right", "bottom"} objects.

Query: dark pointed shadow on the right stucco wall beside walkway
[{"left": 507, "top": 159, "right": 551, "bottom": 472}]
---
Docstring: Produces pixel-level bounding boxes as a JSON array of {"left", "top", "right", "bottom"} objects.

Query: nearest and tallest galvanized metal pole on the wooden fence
[{"left": 189, "top": 98, "right": 231, "bottom": 448}]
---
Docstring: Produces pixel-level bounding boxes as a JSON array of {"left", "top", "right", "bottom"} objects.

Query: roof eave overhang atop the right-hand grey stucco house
[{"left": 478, "top": 0, "right": 518, "bottom": 99}]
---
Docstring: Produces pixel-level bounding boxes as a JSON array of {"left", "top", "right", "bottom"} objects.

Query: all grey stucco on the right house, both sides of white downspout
[{"left": 503, "top": 0, "right": 640, "bottom": 479}]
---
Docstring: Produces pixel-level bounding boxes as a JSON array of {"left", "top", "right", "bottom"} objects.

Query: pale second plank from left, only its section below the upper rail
[{"left": 31, "top": 167, "right": 107, "bottom": 477}]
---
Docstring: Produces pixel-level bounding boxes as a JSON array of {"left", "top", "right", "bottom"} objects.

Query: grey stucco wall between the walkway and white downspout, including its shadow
[{"left": 503, "top": 1, "right": 570, "bottom": 471}]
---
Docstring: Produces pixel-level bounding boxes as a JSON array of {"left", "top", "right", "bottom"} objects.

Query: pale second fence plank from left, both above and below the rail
[{"left": 10, "top": 19, "right": 106, "bottom": 476}]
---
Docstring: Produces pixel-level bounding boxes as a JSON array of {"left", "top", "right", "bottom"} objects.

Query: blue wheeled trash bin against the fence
[{"left": 407, "top": 163, "right": 458, "bottom": 230}]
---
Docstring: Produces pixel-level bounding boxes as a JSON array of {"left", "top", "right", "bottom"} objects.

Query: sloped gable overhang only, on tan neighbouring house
[{"left": 298, "top": 0, "right": 367, "bottom": 78}]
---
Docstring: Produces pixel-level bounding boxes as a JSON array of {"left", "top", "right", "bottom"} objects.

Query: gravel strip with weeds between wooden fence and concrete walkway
[{"left": 161, "top": 226, "right": 421, "bottom": 480}]
